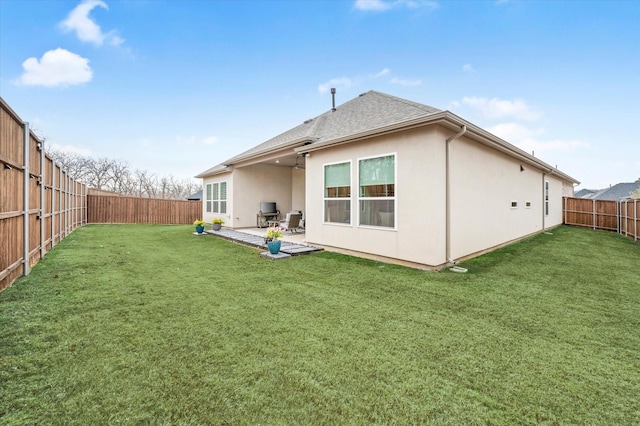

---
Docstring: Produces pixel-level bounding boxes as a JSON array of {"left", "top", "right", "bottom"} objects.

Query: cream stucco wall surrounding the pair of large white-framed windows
[{"left": 305, "top": 128, "right": 445, "bottom": 265}]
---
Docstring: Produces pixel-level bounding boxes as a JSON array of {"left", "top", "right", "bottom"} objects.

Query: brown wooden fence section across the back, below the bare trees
[{"left": 87, "top": 195, "right": 202, "bottom": 224}]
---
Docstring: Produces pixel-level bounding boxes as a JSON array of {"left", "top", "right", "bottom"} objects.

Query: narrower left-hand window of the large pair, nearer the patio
[{"left": 324, "top": 161, "right": 351, "bottom": 224}]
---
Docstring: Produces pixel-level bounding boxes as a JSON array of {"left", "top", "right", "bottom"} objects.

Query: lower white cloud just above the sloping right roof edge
[{"left": 487, "top": 123, "right": 589, "bottom": 154}]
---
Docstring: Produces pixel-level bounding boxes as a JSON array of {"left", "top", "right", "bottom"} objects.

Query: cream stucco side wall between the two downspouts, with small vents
[{"left": 450, "top": 137, "right": 544, "bottom": 260}]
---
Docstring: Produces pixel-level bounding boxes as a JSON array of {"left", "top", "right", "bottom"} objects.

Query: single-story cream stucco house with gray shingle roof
[{"left": 196, "top": 91, "right": 579, "bottom": 268}]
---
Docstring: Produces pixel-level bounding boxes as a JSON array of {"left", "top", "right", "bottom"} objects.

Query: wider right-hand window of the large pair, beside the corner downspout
[{"left": 358, "top": 154, "right": 396, "bottom": 228}]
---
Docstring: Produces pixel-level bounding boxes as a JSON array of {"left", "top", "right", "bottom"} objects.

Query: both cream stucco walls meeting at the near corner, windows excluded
[{"left": 305, "top": 126, "right": 567, "bottom": 266}]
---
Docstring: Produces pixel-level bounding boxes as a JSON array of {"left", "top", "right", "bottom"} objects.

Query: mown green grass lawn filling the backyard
[{"left": 0, "top": 225, "right": 640, "bottom": 425}]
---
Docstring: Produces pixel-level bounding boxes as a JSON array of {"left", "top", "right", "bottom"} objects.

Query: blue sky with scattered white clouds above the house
[{"left": 0, "top": 0, "right": 640, "bottom": 188}]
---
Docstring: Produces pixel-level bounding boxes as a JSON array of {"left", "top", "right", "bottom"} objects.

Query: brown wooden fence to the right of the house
[{"left": 563, "top": 197, "right": 640, "bottom": 241}]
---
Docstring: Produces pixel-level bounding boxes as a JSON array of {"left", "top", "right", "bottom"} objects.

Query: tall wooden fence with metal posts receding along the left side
[{"left": 0, "top": 98, "right": 86, "bottom": 291}]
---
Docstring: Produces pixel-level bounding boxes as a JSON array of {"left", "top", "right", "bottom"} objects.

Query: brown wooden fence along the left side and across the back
[{"left": 0, "top": 98, "right": 202, "bottom": 291}]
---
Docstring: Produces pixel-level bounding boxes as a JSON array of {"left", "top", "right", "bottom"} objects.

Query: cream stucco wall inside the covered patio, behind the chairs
[{"left": 230, "top": 164, "right": 292, "bottom": 228}]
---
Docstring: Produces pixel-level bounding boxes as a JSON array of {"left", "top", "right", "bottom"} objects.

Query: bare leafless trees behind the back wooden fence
[{"left": 47, "top": 149, "right": 202, "bottom": 200}]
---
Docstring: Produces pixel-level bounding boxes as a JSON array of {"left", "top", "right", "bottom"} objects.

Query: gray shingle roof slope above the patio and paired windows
[{"left": 210, "top": 90, "right": 440, "bottom": 168}]
